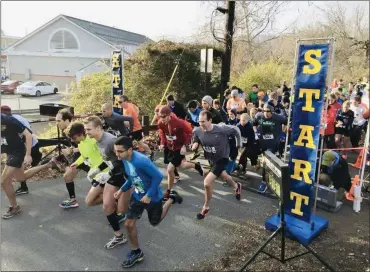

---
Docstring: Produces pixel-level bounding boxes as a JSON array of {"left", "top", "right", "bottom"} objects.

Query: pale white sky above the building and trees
[{"left": 1, "top": 1, "right": 368, "bottom": 40}]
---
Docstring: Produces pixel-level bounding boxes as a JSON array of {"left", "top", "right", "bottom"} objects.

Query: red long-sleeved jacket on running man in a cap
[{"left": 158, "top": 114, "right": 193, "bottom": 151}]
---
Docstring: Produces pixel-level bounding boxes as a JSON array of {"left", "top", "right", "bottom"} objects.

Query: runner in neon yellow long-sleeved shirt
[{"left": 59, "top": 123, "right": 110, "bottom": 208}]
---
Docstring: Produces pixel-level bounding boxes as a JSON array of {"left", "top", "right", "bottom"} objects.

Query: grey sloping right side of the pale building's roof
[{"left": 62, "top": 15, "right": 151, "bottom": 45}]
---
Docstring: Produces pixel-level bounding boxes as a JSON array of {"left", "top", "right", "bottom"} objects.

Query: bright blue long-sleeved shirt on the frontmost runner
[{"left": 121, "top": 151, "right": 163, "bottom": 202}]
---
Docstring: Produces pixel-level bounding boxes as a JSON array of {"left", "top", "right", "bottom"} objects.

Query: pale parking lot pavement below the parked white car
[{"left": 1, "top": 93, "right": 68, "bottom": 110}]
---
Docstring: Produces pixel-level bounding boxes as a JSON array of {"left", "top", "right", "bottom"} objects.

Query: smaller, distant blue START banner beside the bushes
[{"left": 111, "top": 50, "right": 123, "bottom": 114}]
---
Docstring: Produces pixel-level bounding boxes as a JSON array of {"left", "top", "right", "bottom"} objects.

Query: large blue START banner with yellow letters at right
[{"left": 285, "top": 44, "right": 329, "bottom": 221}]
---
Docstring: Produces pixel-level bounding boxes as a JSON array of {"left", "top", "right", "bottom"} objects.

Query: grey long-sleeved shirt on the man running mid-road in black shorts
[{"left": 193, "top": 125, "right": 241, "bottom": 163}]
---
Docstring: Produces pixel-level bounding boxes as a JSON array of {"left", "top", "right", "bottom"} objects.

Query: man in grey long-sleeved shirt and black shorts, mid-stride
[{"left": 192, "top": 111, "right": 242, "bottom": 219}]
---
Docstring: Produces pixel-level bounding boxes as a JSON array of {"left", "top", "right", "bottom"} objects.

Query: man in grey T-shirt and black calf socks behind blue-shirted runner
[{"left": 84, "top": 116, "right": 131, "bottom": 249}]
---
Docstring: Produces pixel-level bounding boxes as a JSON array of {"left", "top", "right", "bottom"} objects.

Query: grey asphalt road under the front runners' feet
[{"left": 1, "top": 158, "right": 277, "bottom": 271}]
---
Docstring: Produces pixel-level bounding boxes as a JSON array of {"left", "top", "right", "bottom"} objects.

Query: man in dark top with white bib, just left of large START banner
[{"left": 253, "top": 103, "right": 287, "bottom": 193}]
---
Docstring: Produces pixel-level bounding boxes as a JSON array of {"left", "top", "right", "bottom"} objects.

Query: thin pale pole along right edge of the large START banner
[{"left": 312, "top": 38, "right": 336, "bottom": 218}]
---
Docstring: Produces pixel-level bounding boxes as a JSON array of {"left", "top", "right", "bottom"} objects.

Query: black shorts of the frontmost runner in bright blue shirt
[{"left": 127, "top": 197, "right": 163, "bottom": 226}]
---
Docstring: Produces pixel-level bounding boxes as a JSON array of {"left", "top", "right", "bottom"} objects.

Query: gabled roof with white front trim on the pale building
[{"left": 4, "top": 14, "right": 151, "bottom": 52}]
